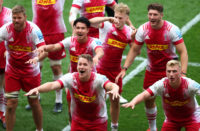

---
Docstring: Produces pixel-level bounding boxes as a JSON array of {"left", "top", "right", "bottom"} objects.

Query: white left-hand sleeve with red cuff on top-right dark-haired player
[{"left": 134, "top": 25, "right": 144, "bottom": 45}]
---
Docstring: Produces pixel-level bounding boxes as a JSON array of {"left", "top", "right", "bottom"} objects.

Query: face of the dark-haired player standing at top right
[{"left": 148, "top": 9, "right": 163, "bottom": 28}]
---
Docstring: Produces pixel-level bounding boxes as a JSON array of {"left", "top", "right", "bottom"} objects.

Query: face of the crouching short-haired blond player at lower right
[{"left": 166, "top": 65, "right": 181, "bottom": 84}]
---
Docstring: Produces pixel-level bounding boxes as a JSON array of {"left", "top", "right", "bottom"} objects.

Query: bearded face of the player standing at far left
[{"left": 12, "top": 13, "right": 26, "bottom": 31}]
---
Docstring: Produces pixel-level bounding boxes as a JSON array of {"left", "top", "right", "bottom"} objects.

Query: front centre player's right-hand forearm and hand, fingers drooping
[{"left": 105, "top": 82, "right": 120, "bottom": 100}]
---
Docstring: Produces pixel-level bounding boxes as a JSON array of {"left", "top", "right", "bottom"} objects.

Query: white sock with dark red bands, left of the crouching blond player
[{"left": 146, "top": 107, "right": 157, "bottom": 131}]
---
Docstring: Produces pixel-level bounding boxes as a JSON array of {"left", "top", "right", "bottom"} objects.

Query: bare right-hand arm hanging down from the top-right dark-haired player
[{"left": 176, "top": 42, "right": 188, "bottom": 76}]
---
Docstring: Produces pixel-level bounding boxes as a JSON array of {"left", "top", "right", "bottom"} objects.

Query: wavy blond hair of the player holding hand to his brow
[{"left": 114, "top": 3, "right": 130, "bottom": 15}]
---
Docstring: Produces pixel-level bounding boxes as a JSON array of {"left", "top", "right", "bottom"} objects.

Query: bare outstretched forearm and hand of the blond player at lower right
[{"left": 122, "top": 90, "right": 151, "bottom": 109}]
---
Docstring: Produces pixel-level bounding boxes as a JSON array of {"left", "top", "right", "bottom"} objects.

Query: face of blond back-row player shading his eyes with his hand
[{"left": 115, "top": 12, "right": 128, "bottom": 29}]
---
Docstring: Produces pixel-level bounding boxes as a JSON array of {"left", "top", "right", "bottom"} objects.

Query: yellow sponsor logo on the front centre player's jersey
[{"left": 74, "top": 93, "right": 96, "bottom": 103}]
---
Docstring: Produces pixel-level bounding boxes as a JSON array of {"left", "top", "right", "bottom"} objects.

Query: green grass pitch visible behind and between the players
[{"left": 0, "top": 0, "right": 200, "bottom": 131}]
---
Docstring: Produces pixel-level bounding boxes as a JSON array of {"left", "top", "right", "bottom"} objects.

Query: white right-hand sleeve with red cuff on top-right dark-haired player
[{"left": 169, "top": 25, "right": 184, "bottom": 45}]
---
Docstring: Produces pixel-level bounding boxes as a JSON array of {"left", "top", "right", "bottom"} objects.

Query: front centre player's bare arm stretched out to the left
[{"left": 25, "top": 81, "right": 61, "bottom": 96}]
